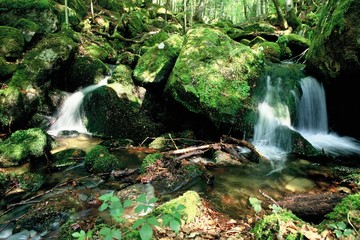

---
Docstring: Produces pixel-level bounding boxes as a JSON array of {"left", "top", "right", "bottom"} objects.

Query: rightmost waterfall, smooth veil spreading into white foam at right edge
[{"left": 296, "top": 77, "right": 360, "bottom": 156}]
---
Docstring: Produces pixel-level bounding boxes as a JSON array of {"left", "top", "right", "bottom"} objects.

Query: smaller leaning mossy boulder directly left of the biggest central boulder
[{"left": 134, "top": 35, "right": 183, "bottom": 83}]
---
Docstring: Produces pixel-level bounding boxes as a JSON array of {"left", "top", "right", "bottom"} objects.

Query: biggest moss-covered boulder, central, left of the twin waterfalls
[{"left": 166, "top": 27, "right": 264, "bottom": 132}]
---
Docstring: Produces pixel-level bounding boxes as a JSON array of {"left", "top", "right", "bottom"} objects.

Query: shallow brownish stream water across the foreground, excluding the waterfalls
[{"left": 0, "top": 135, "right": 358, "bottom": 239}]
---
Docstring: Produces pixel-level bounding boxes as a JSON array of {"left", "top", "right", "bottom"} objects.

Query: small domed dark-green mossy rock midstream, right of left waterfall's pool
[{"left": 85, "top": 145, "right": 126, "bottom": 173}]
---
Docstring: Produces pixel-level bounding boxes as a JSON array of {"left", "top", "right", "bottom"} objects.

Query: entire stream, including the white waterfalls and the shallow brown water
[{"left": 0, "top": 71, "right": 360, "bottom": 239}]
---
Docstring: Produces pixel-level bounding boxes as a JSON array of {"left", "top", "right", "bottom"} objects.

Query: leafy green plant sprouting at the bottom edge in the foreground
[{"left": 72, "top": 192, "right": 185, "bottom": 240}]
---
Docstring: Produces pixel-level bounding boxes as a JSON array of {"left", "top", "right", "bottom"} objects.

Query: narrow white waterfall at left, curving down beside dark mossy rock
[{"left": 47, "top": 76, "right": 110, "bottom": 136}]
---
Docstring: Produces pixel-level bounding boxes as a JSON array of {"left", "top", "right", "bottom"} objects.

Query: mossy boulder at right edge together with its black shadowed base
[{"left": 306, "top": 0, "right": 360, "bottom": 138}]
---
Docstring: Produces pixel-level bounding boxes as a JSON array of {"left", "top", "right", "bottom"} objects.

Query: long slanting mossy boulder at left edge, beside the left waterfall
[{"left": 0, "top": 33, "right": 77, "bottom": 130}]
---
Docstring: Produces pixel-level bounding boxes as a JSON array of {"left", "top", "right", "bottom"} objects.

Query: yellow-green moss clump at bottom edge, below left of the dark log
[{"left": 251, "top": 211, "right": 304, "bottom": 240}]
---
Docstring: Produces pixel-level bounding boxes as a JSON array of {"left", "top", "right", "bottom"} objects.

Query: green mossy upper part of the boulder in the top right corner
[{"left": 306, "top": 0, "right": 360, "bottom": 78}]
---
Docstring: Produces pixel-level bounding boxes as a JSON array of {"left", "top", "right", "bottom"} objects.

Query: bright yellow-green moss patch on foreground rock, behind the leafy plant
[{"left": 154, "top": 191, "right": 202, "bottom": 223}]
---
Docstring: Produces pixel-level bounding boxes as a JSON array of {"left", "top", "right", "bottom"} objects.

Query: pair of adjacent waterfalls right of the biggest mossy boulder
[{"left": 253, "top": 76, "right": 360, "bottom": 168}]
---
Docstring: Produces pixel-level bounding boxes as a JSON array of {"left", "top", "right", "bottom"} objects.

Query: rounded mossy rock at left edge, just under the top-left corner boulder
[{"left": 0, "top": 26, "right": 25, "bottom": 59}]
